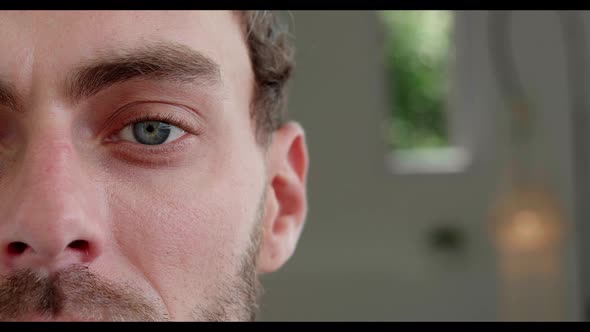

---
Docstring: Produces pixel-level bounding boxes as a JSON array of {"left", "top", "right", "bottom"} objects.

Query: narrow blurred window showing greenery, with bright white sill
[{"left": 379, "top": 10, "right": 466, "bottom": 173}]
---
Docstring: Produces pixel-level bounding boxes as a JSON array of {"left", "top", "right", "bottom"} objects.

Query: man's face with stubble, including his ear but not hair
[{"left": 0, "top": 12, "right": 307, "bottom": 320}]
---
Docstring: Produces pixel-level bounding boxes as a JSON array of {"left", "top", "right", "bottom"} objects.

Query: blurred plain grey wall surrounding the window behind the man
[{"left": 259, "top": 11, "right": 581, "bottom": 321}]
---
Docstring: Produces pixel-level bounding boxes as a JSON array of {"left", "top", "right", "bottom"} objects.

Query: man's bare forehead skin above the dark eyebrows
[{"left": 0, "top": 11, "right": 248, "bottom": 90}]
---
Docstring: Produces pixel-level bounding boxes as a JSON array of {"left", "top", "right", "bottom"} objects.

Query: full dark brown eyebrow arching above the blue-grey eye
[{"left": 65, "top": 42, "right": 222, "bottom": 101}]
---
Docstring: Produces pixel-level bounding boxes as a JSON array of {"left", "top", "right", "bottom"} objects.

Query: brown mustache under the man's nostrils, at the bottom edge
[{"left": 0, "top": 265, "right": 168, "bottom": 321}]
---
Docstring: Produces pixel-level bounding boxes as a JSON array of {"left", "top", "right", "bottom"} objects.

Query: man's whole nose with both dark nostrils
[{"left": 0, "top": 142, "right": 104, "bottom": 272}]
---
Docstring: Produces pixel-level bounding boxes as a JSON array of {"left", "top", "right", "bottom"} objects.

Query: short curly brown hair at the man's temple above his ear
[{"left": 237, "top": 11, "right": 295, "bottom": 145}]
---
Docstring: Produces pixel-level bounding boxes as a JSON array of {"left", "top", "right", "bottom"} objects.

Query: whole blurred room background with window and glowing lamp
[{"left": 259, "top": 11, "right": 590, "bottom": 321}]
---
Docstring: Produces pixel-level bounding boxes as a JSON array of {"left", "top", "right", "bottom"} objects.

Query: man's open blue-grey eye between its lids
[{"left": 121, "top": 121, "right": 184, "bottom": 145}]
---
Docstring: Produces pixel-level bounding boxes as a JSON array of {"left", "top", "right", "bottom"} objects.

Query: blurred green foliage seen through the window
[{"left": 379, "top": 11, "right": 453, "bottom": 149}]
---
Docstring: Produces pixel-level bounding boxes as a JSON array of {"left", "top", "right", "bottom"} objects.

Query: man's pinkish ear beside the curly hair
[{"left": 257, "top": 122, "right": 309, "bottom": 273}]
